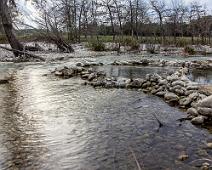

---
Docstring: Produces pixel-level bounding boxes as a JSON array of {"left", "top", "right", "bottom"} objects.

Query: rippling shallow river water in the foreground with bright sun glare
[{"left": 0, "top": 55, "right": 212, "bottom": 170}]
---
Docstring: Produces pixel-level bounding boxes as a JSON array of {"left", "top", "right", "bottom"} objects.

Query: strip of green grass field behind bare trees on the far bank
[{"left": 0, "top": 33, "right": 211, "bottom": 49}]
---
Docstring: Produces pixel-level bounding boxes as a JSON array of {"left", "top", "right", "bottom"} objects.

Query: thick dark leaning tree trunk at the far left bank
[{"left": 0, "top": 0, "right": 23, "bottom": 57}]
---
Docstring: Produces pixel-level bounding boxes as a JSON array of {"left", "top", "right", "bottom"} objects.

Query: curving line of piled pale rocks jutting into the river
[{"left": 53, "top": 63, "right": 212, "bottom": 125}]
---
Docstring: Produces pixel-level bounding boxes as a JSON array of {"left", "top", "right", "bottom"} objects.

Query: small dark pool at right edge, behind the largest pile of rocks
[{"left": 189, "top": 69, "right": 212, "bottom": 84}]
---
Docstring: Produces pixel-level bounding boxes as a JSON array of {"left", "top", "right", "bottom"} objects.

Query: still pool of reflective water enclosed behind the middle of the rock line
[{"left": 96, "top": 65, "right": 176, "bottom": 78}]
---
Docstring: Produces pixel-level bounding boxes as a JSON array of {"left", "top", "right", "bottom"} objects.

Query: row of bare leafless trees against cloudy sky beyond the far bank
[{"left": 1, "top": 0, "right": 212, "bottom": 46}]
